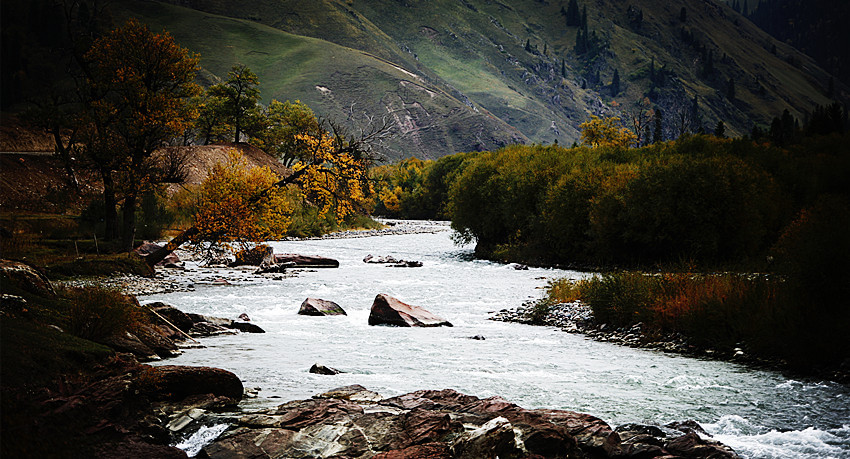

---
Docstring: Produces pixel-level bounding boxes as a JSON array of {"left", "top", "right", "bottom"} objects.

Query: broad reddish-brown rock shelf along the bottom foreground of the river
[{"left": 186, "top": 385, "right": 738, "bottom": 459}]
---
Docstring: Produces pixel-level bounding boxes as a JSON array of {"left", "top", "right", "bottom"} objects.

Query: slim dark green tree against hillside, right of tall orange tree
[{"left": 207, "top": 64, "right": 260, "bottom": 142}]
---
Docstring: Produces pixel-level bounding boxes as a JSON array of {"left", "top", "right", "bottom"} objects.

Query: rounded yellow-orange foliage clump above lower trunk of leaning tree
[{"left": 192, "top": 150, "right": 292, "bottom": 248}]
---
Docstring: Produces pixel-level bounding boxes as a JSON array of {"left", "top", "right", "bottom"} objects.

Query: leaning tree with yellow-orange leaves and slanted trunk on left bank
[{"left": 146, "top": 117, "right": 382, "bottom": 265}]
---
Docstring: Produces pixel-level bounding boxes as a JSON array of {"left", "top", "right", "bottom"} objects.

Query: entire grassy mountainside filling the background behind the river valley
[{"left": 117, "top": 0, "right": 847, "bottom": 158}]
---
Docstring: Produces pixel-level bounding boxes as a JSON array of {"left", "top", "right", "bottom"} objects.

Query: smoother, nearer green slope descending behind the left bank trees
[{"left": 114, "top": 1, "right": 527, "bottom": 159}]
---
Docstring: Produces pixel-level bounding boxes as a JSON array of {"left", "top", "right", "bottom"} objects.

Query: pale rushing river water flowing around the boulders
[{"left": 141, "top": 231, "right": 850, "bottom": 458}]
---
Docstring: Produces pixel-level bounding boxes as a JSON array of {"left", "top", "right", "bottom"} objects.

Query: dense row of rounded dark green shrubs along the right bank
[{"left": 373, "top": 135, "right": 850, "bottom": 266}]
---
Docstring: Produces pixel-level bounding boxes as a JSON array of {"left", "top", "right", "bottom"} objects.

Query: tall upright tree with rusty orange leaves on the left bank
[{"left": 85, "top": 19, "right": 200, "bottom": 250}]
